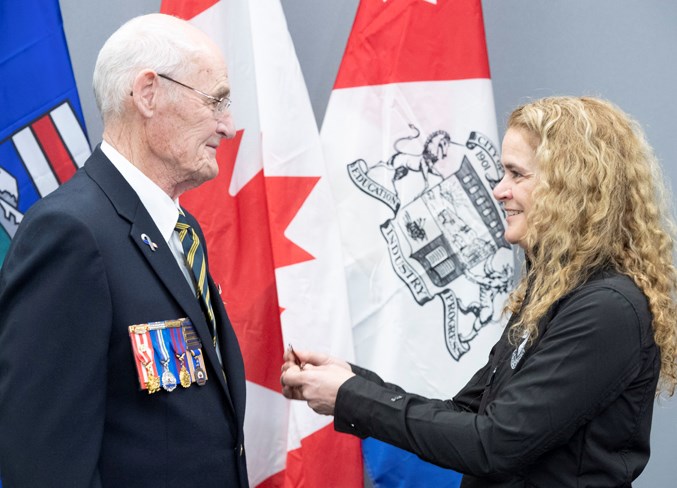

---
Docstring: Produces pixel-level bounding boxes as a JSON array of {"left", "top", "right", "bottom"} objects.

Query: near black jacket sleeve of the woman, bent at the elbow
[{"left": 335, "top": 288, "right": 642, "bottom": 476}]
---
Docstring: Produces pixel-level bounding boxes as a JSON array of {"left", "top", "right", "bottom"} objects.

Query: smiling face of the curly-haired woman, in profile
[{"left": 494, "top": 128, "right": 537, "bottom": 249}]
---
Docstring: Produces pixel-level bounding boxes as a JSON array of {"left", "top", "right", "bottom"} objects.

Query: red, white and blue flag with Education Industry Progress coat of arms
[{"left": 321, "top": 0, "right": 514, "bottom": 487}]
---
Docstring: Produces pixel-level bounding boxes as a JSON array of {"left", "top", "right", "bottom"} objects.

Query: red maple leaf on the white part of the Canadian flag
[{"left": 181, "top": 131, "right": 319, "bottom": 392}]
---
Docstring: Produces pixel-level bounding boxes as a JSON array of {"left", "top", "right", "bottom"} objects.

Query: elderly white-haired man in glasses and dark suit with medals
[{"left": 0, "top": 14, "right": 248, "bottom": 488}]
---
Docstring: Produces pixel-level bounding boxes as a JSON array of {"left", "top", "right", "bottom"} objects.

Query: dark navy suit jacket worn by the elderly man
[{"left": 0, "top": 148, "right": 247, "bottom": 488}]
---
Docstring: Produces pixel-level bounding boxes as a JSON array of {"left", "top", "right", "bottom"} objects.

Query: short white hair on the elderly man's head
[{"left": 93, "top": 14, "right": 208, "bottom": 124}]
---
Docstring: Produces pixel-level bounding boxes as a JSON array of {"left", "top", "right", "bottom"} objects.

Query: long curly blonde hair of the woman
[{"left": 507, "top": 97, "right": 677, "bottom": 396}]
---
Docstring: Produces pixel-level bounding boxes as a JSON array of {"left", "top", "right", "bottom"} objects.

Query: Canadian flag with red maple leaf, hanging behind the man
[{"left": 161, "top": 0, "right": 363, "bottom": 488}]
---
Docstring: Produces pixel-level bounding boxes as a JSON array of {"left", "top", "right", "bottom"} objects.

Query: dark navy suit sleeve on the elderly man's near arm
[{"left": 0, "top": 207, "right": 112, "bottom": 487}]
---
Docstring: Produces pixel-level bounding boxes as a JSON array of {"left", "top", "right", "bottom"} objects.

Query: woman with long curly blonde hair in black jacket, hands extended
[{"left": 281, "top": 97, "right": 677, "bottom": 488}]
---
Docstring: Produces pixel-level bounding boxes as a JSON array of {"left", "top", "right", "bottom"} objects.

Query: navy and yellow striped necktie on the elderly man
[{"left": 174, "top": 208, "right": 216, "bottom": 347}]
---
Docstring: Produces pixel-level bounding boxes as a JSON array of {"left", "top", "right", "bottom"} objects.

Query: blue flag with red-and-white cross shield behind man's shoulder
[{"left": 0, "top": 0, "right": 90, "bottom": 266}]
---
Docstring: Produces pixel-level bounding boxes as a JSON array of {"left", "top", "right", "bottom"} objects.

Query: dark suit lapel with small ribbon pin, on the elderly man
[{"left": 84, "top": 147, "right": 234, "bottom": 410}]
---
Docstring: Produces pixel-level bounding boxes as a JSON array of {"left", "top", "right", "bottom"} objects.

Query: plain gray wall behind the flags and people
[{"left": 61, "top": 0, "right": 677, "bottom": 488}]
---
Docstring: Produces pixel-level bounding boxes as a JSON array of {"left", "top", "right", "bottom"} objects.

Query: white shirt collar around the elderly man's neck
[{"left": 101, "top": 141, "right": 179, "bottom": 242}]
